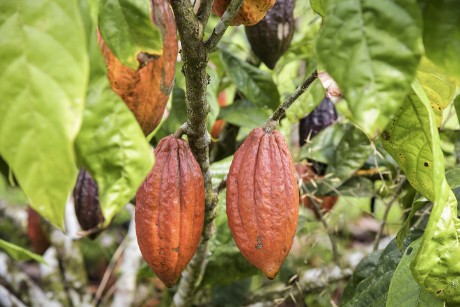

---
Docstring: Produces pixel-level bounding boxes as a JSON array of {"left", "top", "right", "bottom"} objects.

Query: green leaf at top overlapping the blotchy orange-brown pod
[{"left": 99, "top": 0, "right": 163, "bottom": 69}]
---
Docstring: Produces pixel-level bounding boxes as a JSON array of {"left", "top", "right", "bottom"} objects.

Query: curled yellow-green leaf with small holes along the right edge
[{"left": 382, "top": 82, "right": 460, "bottom": 303}]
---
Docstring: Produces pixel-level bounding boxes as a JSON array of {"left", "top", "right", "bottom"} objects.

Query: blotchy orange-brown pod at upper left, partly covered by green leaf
[{"left": 98, "top": 0, "right": 178, "bottom": 135}]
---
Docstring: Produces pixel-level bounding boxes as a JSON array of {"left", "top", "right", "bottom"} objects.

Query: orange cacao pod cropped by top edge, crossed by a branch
[{"left": 212, "top": 0, "right": 276, "bottom": 26}]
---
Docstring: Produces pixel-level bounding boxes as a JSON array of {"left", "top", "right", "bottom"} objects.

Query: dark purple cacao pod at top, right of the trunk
[{"left": 245, "top": 0, "right": 295, "bottom": 69}]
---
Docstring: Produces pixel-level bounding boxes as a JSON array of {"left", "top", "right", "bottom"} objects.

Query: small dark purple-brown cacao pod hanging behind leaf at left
[{"left": 73, "top": 169, "right": 104, "bottom": 239}]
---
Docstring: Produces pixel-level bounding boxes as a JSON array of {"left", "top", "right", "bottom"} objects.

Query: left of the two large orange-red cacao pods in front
[{"left": 135, "top": 135, "right": 204, "bottom": 287}]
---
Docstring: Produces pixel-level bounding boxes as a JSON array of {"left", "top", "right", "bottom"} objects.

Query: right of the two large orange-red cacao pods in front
[{"left": 227, "top": 128, "right": 299, "bottom": 279}]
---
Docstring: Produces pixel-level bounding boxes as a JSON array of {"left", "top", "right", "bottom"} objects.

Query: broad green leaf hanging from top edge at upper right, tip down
[{"left": 316, "top": 0, "right": 423, "bottom": 137}]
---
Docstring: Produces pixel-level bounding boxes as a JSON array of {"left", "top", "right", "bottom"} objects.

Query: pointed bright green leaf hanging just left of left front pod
[{"left": 76, "top": 3, "right": 153, "bottom": 225}]
